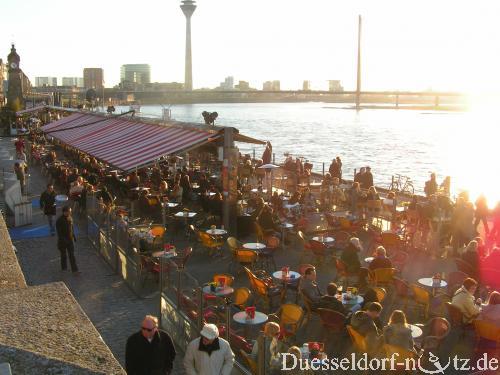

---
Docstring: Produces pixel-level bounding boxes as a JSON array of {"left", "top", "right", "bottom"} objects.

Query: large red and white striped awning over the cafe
[{"left": 42, "top": 113, "right": 215, "bottom": 171}]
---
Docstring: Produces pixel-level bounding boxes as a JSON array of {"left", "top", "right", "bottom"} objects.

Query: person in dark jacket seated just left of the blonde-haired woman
[{"left": 351, "top": 302, "right": 382, "bottom": 355}]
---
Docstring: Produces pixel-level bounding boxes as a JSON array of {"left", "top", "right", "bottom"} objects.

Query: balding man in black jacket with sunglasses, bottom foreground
[{"left": 125, "top": 315, "right": 176, "bottom": 375}]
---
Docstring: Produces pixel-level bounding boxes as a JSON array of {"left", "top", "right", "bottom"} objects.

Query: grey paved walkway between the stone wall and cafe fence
[{"left": 1, "top": 139, "right": 184, "bottom": 374}]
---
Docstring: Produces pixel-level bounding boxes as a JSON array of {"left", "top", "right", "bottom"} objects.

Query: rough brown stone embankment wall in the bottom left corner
[{"left": 0, "top": 216, "right": 125, "bottom": 374}]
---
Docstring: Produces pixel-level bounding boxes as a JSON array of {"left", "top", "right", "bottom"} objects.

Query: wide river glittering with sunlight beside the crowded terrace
[{"left": 117, "top": 103, "right": 500, "bottom": 206}]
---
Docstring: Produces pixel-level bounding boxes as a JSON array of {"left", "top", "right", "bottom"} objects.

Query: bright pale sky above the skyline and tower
[{"left": 0, "top": 0, "right": 500, "bottom": 93}]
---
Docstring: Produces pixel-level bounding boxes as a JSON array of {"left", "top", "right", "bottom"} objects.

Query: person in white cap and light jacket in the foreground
[{"left": 184, "top": 324, "right": 234, "bottom": 375}]
